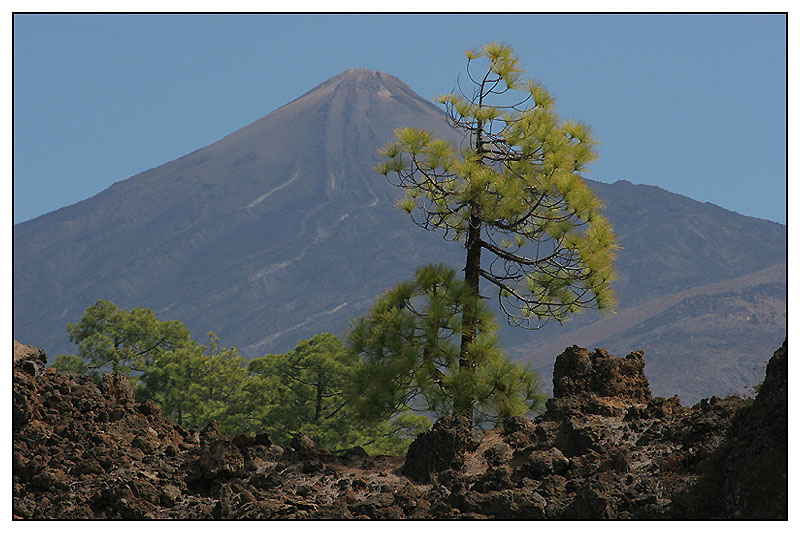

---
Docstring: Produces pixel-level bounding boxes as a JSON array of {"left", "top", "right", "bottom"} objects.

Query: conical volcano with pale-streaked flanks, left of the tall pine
[{"left": 14, "top": 68, "right": 462, "bottom": 355}]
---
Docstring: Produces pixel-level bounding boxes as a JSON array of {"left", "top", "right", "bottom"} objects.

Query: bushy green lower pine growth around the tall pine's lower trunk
[{"left": 348, "top": 265, "right": 543, "bottom": 424}]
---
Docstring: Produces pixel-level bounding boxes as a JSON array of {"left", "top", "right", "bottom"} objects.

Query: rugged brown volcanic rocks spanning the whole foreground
[{"left": 12, "top": 343, "right": 788, "bottom": 520}]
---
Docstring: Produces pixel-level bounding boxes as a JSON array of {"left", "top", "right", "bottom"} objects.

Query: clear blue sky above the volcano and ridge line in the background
[{"left": 13, "top": 15, "right": 786, "bottom": 223}]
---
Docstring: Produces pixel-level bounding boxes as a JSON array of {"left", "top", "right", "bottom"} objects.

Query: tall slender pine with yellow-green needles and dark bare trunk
[{"left": 376, "top": 43, "right": 618, "bottom": 416}]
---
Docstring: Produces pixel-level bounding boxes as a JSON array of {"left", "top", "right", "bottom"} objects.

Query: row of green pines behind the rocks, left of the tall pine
[{"left": 53, "top": 300, "right": 431, "bottom": 454}]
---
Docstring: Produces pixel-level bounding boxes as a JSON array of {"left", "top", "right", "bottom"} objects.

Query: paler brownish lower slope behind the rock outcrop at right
[{"left": 514, "top": 263, "right": 786, "bottom": 405}]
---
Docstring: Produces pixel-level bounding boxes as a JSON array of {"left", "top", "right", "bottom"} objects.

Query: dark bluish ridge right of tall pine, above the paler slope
[{"left": 496, "top": 180, "right": 786, "bottom": 350}]
